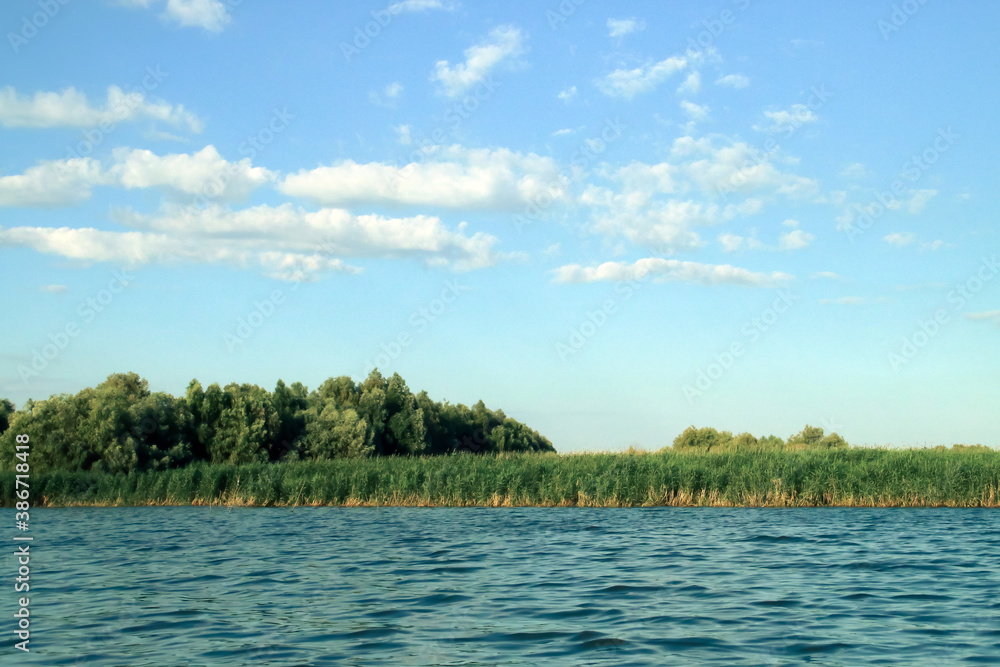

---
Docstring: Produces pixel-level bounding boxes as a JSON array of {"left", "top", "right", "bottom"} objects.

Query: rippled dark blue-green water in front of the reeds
[{"left": 0, "top": 507, "right": 1000, "bottom": 667}]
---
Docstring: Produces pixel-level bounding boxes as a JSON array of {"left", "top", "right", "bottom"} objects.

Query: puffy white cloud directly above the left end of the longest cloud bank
[{"left": 108, "top": 145, "right": 277, "bottom": 201}]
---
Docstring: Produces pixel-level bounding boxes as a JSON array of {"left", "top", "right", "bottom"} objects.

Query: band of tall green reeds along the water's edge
[{"left": 0, "top": 449, "right": 1000, "bottom": 507}]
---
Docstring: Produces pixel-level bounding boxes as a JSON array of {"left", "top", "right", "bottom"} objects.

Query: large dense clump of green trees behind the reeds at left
[{"left": 0, "top": 369, "right": 555, "bottom": 472}]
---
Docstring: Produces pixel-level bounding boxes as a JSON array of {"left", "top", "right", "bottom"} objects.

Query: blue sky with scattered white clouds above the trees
[{"left": 0, "top": 0, "right": 1000, "bottom": 452}]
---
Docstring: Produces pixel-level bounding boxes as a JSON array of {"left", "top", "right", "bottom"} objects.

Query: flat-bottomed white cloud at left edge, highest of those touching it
[{"left": 0, "top": 86, "right": 202, "bottom": 132}]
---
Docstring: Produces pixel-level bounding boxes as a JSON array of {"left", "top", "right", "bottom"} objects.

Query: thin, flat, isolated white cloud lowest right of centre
[{"left": 553, "top": 257, "right": 794, "bottom": 287}]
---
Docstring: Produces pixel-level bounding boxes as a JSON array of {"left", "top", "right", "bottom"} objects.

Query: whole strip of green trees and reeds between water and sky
[{"left": 0, "top": 370, "right": 1000, "bottom": 507}]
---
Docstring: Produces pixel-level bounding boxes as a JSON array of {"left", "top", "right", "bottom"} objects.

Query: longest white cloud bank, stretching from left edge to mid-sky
[{"left": 0, "top": 204, "right": 512, "bottom": 280}]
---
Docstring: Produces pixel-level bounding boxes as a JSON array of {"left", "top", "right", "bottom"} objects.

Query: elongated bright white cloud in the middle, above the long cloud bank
[{"left": 278, "top": 146, "right": 567, "bottom": 210}]
